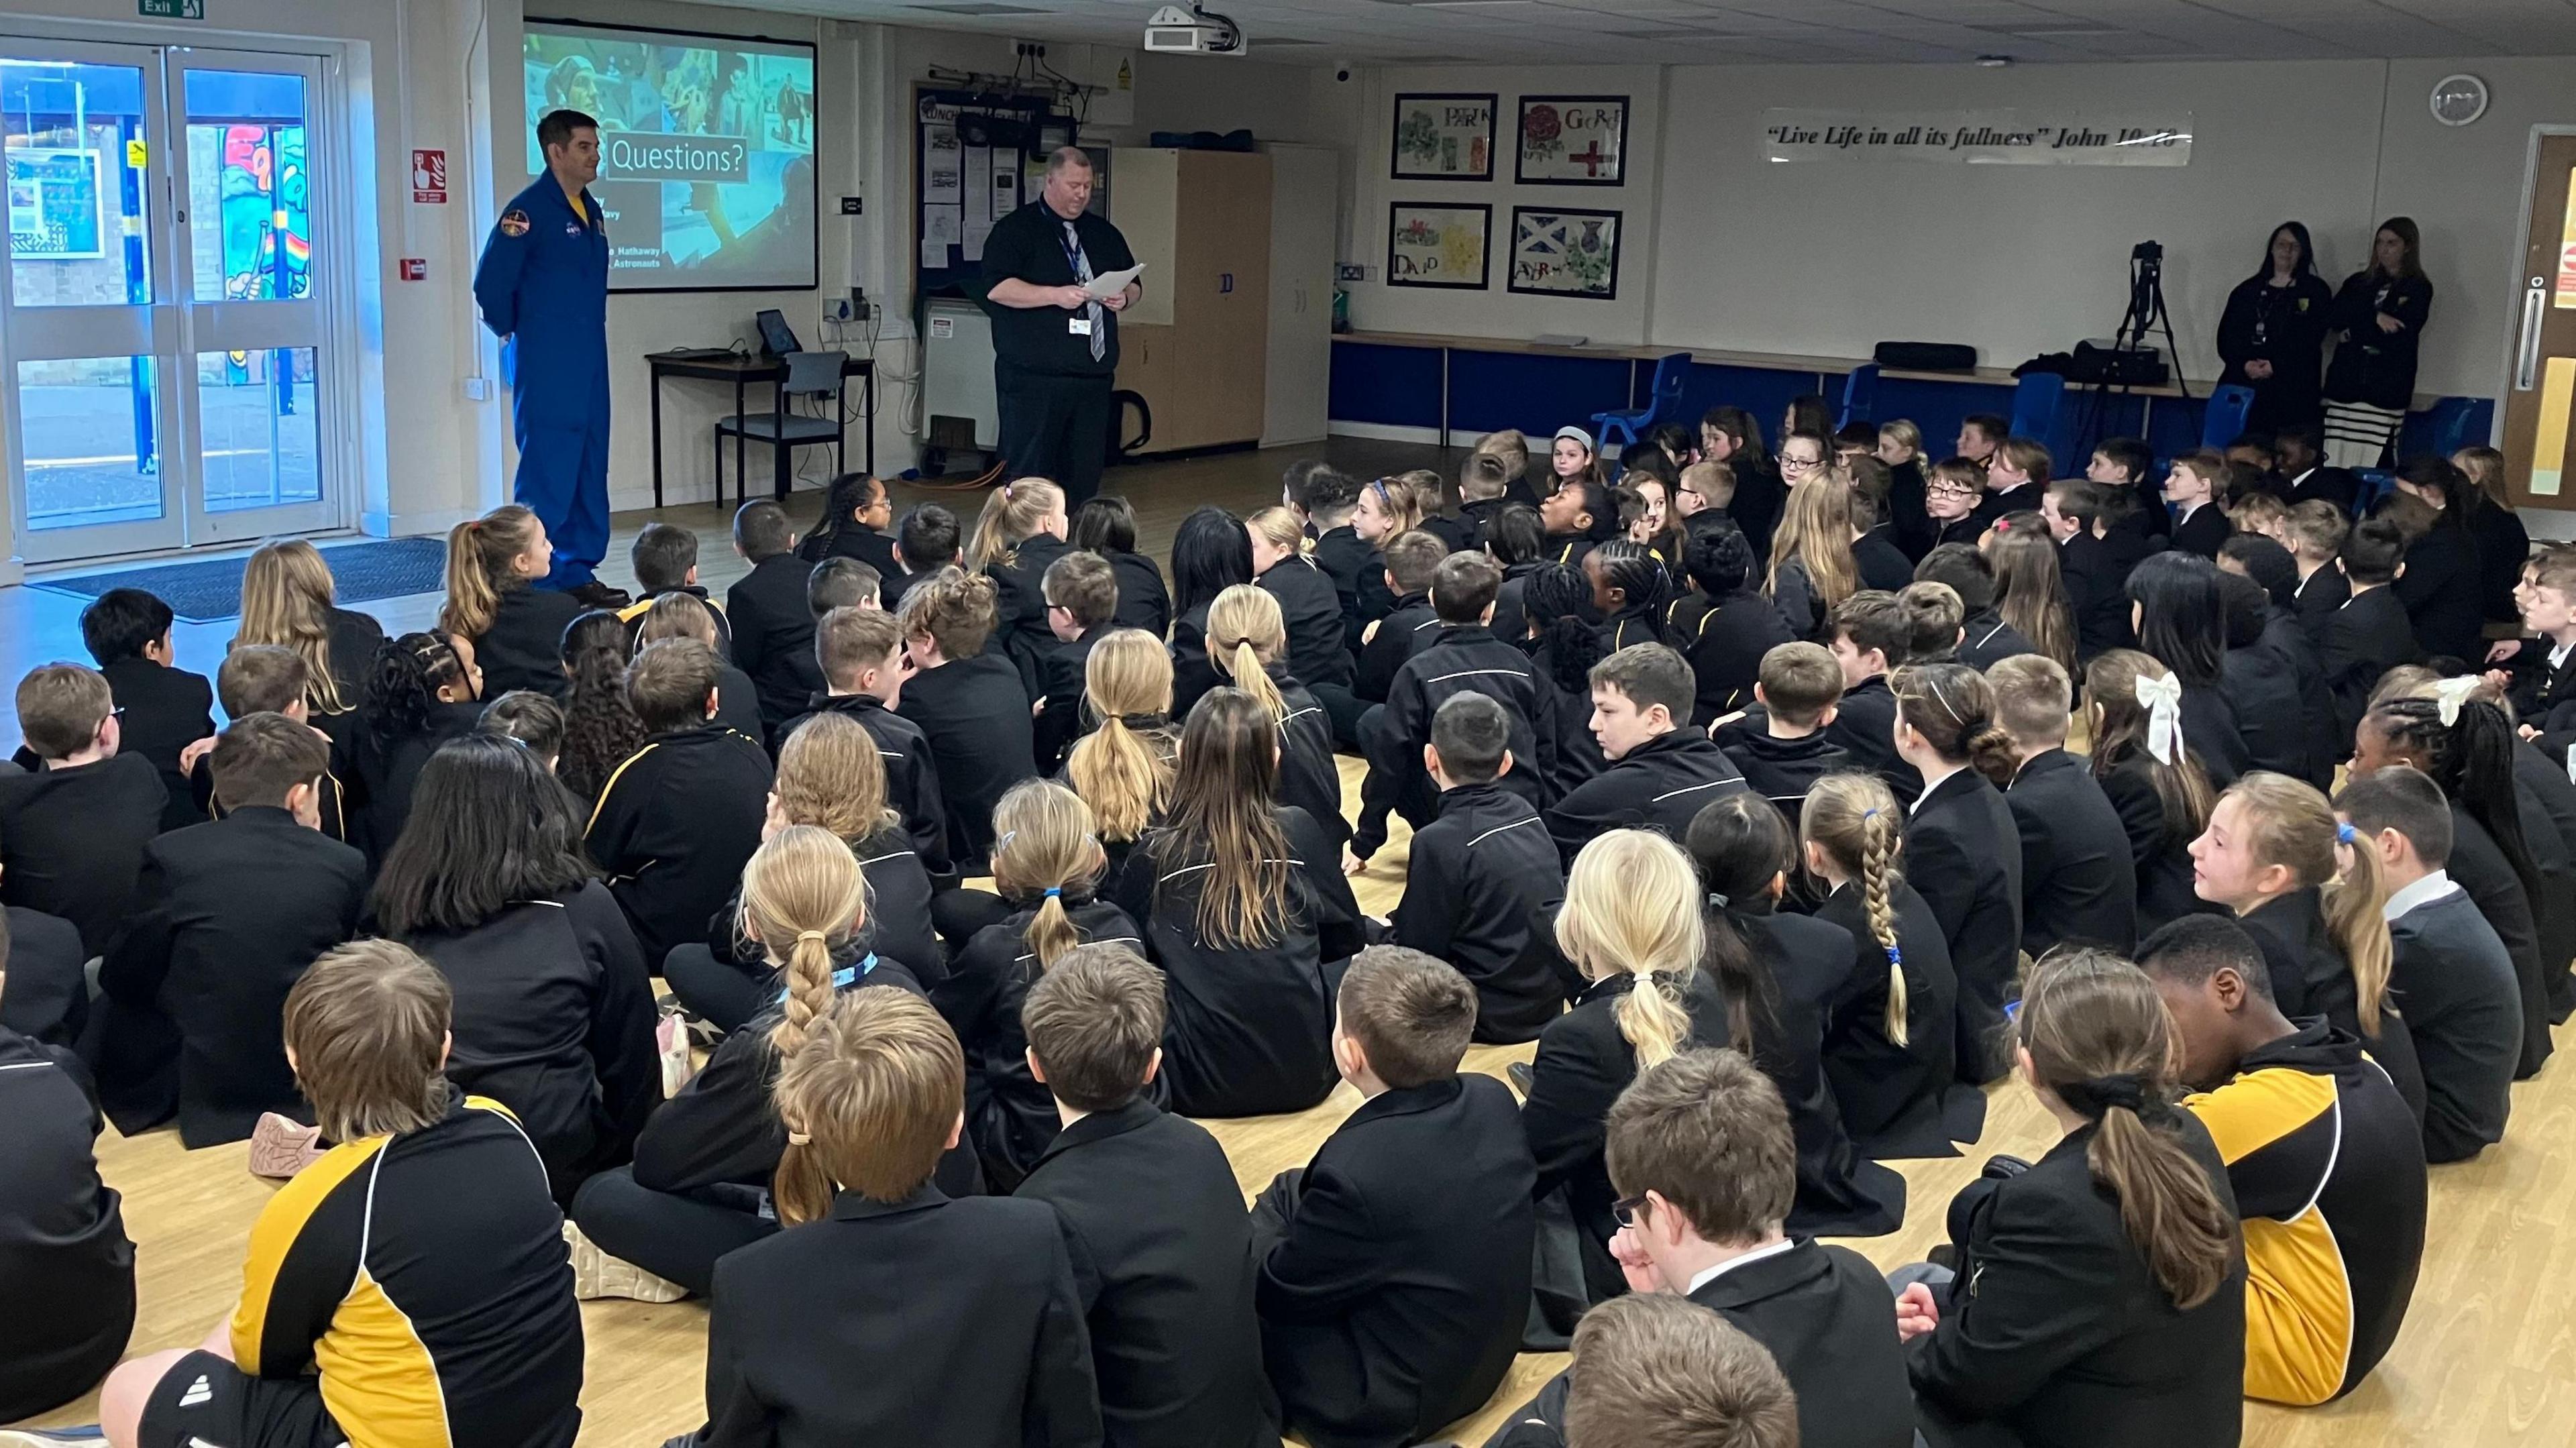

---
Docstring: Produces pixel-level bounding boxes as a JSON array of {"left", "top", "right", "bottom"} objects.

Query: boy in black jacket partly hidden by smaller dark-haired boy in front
[{"left": 1344, "top": 554, "right": 1546, "bottom": 869}]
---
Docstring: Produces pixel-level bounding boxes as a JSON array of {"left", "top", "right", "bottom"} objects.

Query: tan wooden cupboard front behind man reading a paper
[{"left": 1110, "top": 147, "right": 1270, "bottom": 453}]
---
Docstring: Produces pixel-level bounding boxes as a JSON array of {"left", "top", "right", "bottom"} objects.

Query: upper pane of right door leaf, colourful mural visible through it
[{"left": 188, "top": 70, "right": 312, "bottom": 301}]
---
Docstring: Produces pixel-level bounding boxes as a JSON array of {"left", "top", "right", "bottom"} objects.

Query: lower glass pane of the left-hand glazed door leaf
[{"left": 18, "top": 358, "right": 162, "bottom": 528}]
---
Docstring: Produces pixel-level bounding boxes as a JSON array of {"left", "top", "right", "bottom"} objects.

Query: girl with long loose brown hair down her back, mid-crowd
[{"left": 1118, "top": 688, "right": 1362, "bottom": 1115}]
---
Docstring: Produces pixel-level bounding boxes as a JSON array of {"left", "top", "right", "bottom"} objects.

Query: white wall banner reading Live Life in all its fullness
[{"left": 1762, "top": 108, "right": 2192, "bottom": 165}]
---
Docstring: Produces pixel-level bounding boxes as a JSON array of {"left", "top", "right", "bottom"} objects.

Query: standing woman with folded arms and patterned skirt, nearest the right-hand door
[{"left": 2324, "top": 217, "right": 2432, "bottom": 466}]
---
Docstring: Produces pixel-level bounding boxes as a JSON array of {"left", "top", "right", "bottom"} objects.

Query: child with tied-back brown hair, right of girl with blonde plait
[{"left": 1893, "top": 665, "right": 2022, "bottom": 1084}]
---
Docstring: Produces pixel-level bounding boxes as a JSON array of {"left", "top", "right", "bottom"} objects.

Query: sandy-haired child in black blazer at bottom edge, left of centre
[{"left": 698, "top": 987, "right": 1100, "bottom": 1448}]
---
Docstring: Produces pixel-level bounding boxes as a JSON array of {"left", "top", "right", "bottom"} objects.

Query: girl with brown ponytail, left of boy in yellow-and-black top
[{"left": 1896, "top": 951, "right": 2246, "bottom": 1448}]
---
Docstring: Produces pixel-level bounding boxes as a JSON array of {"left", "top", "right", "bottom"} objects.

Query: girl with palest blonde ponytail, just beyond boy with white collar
[{"left": 1520, "top": 830, "right": 1731, "bottom": 1301}]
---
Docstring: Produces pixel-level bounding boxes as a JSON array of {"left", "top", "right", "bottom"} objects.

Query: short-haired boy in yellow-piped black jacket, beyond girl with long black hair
[{"left": 585, "top": 634, "right": 770, "bottom": 961}]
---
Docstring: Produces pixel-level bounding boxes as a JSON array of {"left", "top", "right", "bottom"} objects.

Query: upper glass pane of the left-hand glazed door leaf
[{"left": 0, "top": 62, "right": 152, "bottom": 307}]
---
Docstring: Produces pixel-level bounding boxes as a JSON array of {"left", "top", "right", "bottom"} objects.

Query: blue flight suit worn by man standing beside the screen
[{"left": 474, "top": 175, "right": 608, "bottom": 590}]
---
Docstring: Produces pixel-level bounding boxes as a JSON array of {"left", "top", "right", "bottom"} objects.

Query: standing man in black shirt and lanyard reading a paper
[{"left": 984, "top": 147, "right": 1144, "bottom": 508}]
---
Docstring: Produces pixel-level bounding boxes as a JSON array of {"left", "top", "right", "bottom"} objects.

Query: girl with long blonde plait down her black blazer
[{"left": 1798, "top": 771, "right": 1986, "bottom": 1160}]
